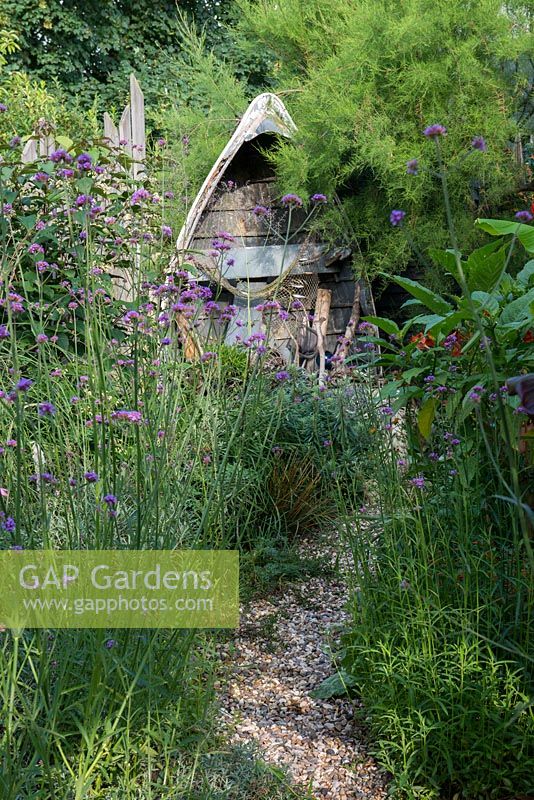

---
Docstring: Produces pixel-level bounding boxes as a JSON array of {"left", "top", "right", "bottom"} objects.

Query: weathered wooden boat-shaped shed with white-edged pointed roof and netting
[{"left": 177, "top": 94, "right": 372, "bottom": 369}]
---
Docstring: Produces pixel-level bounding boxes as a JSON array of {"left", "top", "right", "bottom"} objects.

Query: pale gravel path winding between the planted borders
[{"left": 221, "top": 551, "right": 387, "bottom": 800}]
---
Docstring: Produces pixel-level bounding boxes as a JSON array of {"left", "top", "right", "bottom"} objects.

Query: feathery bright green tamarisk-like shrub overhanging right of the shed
[{"left": 240, "top": 0, "right": 532, "bottom": 278}]
